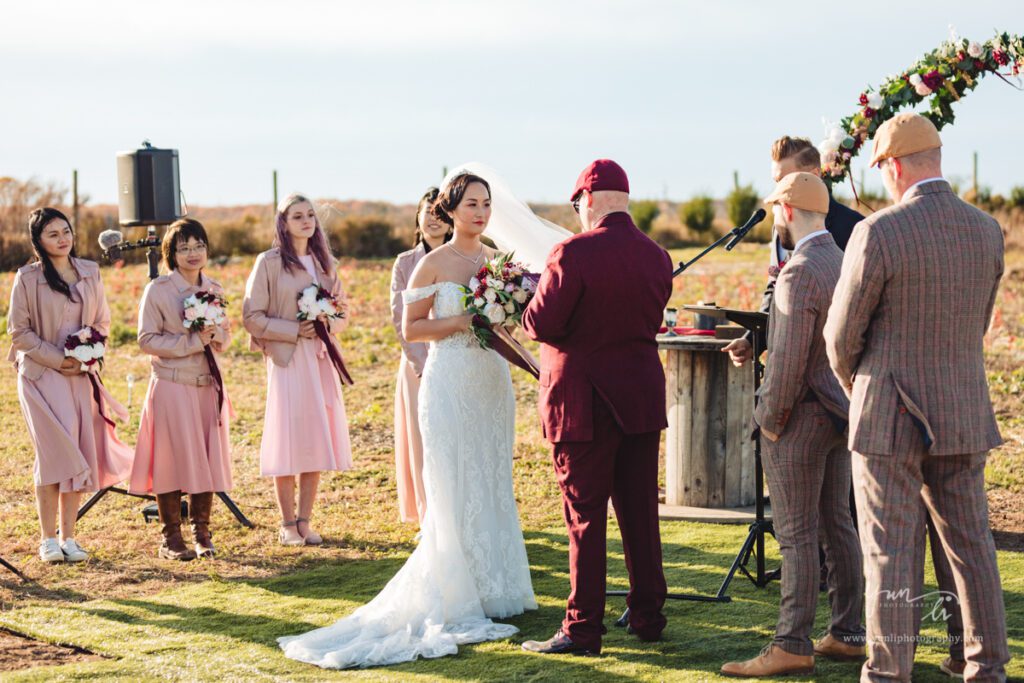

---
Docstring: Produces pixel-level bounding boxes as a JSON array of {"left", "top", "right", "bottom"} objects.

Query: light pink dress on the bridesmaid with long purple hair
[{"left": 260, "top": 256, "right": 352, "bottom": 476}]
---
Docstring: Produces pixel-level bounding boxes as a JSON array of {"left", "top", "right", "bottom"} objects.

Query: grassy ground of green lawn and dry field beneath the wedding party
[{"left": 0, "top": 245, "right": 1024, "bottom": 681}]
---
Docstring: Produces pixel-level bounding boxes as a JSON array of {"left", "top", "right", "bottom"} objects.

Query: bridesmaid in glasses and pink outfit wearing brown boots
[{"left": 131, "top": 218, "right": 231, "bottom": 560}]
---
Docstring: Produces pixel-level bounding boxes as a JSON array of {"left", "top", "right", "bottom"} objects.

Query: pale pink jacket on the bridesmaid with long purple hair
[{"left": 242, "top": 247, "right": 348, "bottom": 368}]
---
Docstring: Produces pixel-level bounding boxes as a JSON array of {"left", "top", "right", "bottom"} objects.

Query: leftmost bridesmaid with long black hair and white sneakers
[{"left": 7, "top": 208, "right": 132, "bottom": 562}]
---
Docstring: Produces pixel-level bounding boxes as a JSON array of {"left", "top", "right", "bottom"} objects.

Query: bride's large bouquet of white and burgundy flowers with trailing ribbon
[{"left": 463, "top": 252, "right": 540, "bottom": 377}]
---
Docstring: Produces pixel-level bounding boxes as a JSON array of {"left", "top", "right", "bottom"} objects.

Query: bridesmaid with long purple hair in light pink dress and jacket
[{"left": 242, "top": 195, "right": 352, "bottom": 546}]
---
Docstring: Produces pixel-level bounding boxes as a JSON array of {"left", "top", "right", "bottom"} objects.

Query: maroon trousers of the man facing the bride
[{"left": 554, "top": 395, "right": 668, "bottom": 652}]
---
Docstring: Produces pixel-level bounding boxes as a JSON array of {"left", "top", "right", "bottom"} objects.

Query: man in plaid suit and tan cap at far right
[{"left": 825, "top": 114, "right": 1010, "bottom": 681}]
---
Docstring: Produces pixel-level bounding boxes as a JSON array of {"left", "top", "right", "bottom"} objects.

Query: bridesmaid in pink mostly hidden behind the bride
[{"left": 391, "top": 187, "right": 452, "bottom": 522}]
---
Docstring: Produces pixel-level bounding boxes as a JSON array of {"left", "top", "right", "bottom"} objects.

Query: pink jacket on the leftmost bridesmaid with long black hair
[{"left": 7, "top": 258, "right": 111, "bottom": 380}]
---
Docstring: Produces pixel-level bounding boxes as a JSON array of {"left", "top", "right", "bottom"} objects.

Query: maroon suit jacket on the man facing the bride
[{"left": 522, "top": 212, "right": 672, "bottom": 443}]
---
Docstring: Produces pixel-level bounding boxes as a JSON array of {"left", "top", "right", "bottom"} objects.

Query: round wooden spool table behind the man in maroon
[{"left": 657, "top": 335, "right": 755, "bottom": 508}]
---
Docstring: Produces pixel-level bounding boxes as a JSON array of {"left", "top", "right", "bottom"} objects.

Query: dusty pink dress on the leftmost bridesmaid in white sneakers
[{"left": 17, "top": 281, "right": 132, "bottom": 494}]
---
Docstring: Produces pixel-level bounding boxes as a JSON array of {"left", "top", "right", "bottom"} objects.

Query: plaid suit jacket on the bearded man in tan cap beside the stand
[{"left": 754, "top": 229, "right": 850, "bottom": 434}]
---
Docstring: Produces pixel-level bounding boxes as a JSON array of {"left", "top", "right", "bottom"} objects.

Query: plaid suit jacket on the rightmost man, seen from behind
[{"left": 825, "top": 180, "right": 1004, "bottom": 456}]
